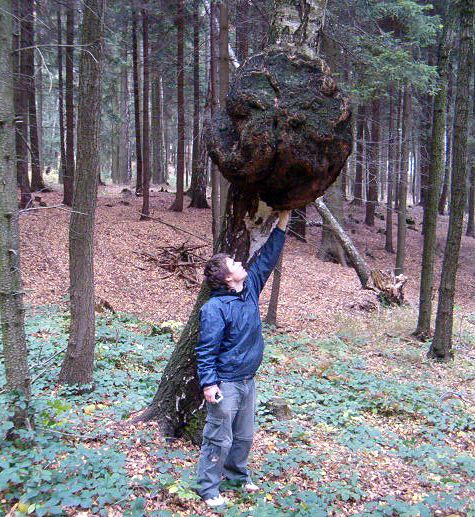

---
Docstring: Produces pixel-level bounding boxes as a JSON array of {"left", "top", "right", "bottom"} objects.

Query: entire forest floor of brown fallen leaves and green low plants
[{"left": 0, "top": 187, "right": 475, "bottom": 517}]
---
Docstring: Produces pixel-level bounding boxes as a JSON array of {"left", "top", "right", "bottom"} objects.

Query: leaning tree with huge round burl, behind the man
[{"left": 134, "top": 0, "right": 351, "bottom": 438}]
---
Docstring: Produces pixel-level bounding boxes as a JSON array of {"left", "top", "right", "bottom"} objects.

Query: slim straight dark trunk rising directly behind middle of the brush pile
[{"left": 170, "top": 0, "right": 185, "bottom": 212}]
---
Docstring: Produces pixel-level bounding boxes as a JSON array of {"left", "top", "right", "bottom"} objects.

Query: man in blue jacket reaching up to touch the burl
[{"left": 196, "top": 210, "right": 290, "bottom": 508}]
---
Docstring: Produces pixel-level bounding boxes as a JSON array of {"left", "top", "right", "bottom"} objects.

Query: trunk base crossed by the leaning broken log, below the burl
[{"left": 318, "top": 176, "right": 347, "bottom": 267}]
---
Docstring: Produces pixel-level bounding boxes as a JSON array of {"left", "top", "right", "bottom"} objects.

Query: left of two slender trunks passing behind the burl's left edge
[{"left": 209, "top": 0, "right": 221, "bottom": 244}]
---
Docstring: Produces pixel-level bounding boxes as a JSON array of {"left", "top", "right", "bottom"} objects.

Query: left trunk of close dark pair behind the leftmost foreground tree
[{"left": 13, "top": 0, "right": 32, "bottom": 208}]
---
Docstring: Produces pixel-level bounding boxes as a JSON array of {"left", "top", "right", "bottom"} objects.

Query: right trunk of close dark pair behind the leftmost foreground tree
[{"left": 21, "top": 0, "right": 45, "bottom": 191}]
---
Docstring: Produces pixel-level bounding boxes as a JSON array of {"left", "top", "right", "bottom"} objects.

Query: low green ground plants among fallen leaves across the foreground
[{"left": 0, "top": 307, "right": 475, "bottom": 517}]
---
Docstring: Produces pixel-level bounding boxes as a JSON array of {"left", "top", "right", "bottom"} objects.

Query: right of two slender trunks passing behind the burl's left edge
[{"left": 219, "top": 0, "right": 229, "bottom": 221}]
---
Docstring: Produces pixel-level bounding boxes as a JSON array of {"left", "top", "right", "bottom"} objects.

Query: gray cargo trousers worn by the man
[{"left": 197, "top": 379, "right": 256, "bottom": 499}]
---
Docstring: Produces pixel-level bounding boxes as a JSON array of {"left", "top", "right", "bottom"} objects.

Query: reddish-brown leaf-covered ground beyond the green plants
[{"left": 21, "top": 186, "right": 475, "bottom": 337}]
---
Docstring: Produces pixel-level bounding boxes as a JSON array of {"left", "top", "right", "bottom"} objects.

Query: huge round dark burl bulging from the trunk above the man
[{"left": 206, "top": 50, "right": 352, "bottom": 210}]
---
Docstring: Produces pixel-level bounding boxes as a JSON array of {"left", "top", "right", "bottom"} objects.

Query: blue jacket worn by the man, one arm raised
[{"left": 196, "top": 228, "right": 285, "bottom": 388}]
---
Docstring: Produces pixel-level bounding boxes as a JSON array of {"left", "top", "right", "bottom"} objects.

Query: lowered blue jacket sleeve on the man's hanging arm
[{"left": 195, "top": 305, "right": 226, "bottom": 388}]
